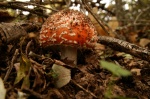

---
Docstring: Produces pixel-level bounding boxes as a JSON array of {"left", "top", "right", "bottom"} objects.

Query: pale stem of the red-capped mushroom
[{"left": 60, "top": 46, "right": 77, "bottom": 65}]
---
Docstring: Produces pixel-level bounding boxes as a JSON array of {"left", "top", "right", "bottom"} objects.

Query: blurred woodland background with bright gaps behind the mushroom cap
[{"left": 0, "top": 0, "right": 150, "bottom": 44}]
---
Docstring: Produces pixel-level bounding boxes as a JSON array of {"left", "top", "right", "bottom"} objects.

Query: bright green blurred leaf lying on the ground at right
[{"left": 100, "top": 60, "right": 131, "bottom": 77}]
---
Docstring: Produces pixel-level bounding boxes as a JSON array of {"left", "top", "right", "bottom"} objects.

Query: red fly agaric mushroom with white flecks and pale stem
[{"left": 39, "top": 9, "right": 97, "bottom": 64}]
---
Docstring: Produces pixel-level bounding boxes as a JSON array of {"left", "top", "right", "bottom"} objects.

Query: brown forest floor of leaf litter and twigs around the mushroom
[{"left": 0, "top": 24, "right": 150, "bottom": 99}]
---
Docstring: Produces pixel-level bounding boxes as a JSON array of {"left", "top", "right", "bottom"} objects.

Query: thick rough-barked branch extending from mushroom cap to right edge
[{"left": 98, "top": 36, "right": 150, "bottom": 62}]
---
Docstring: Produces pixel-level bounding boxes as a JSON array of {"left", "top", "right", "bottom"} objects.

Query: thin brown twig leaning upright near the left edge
[{"left": 4, "top": 49, "right": 19, "bottom": 82}]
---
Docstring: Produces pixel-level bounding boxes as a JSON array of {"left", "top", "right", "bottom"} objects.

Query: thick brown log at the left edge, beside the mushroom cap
[{"left": 0, "top": 23, "right": 41, "bottom": 46}]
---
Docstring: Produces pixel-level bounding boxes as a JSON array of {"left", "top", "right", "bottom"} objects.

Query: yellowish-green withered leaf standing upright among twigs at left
[{"left": 14, "top": 54, "right": 31, "bottom": 84}]
